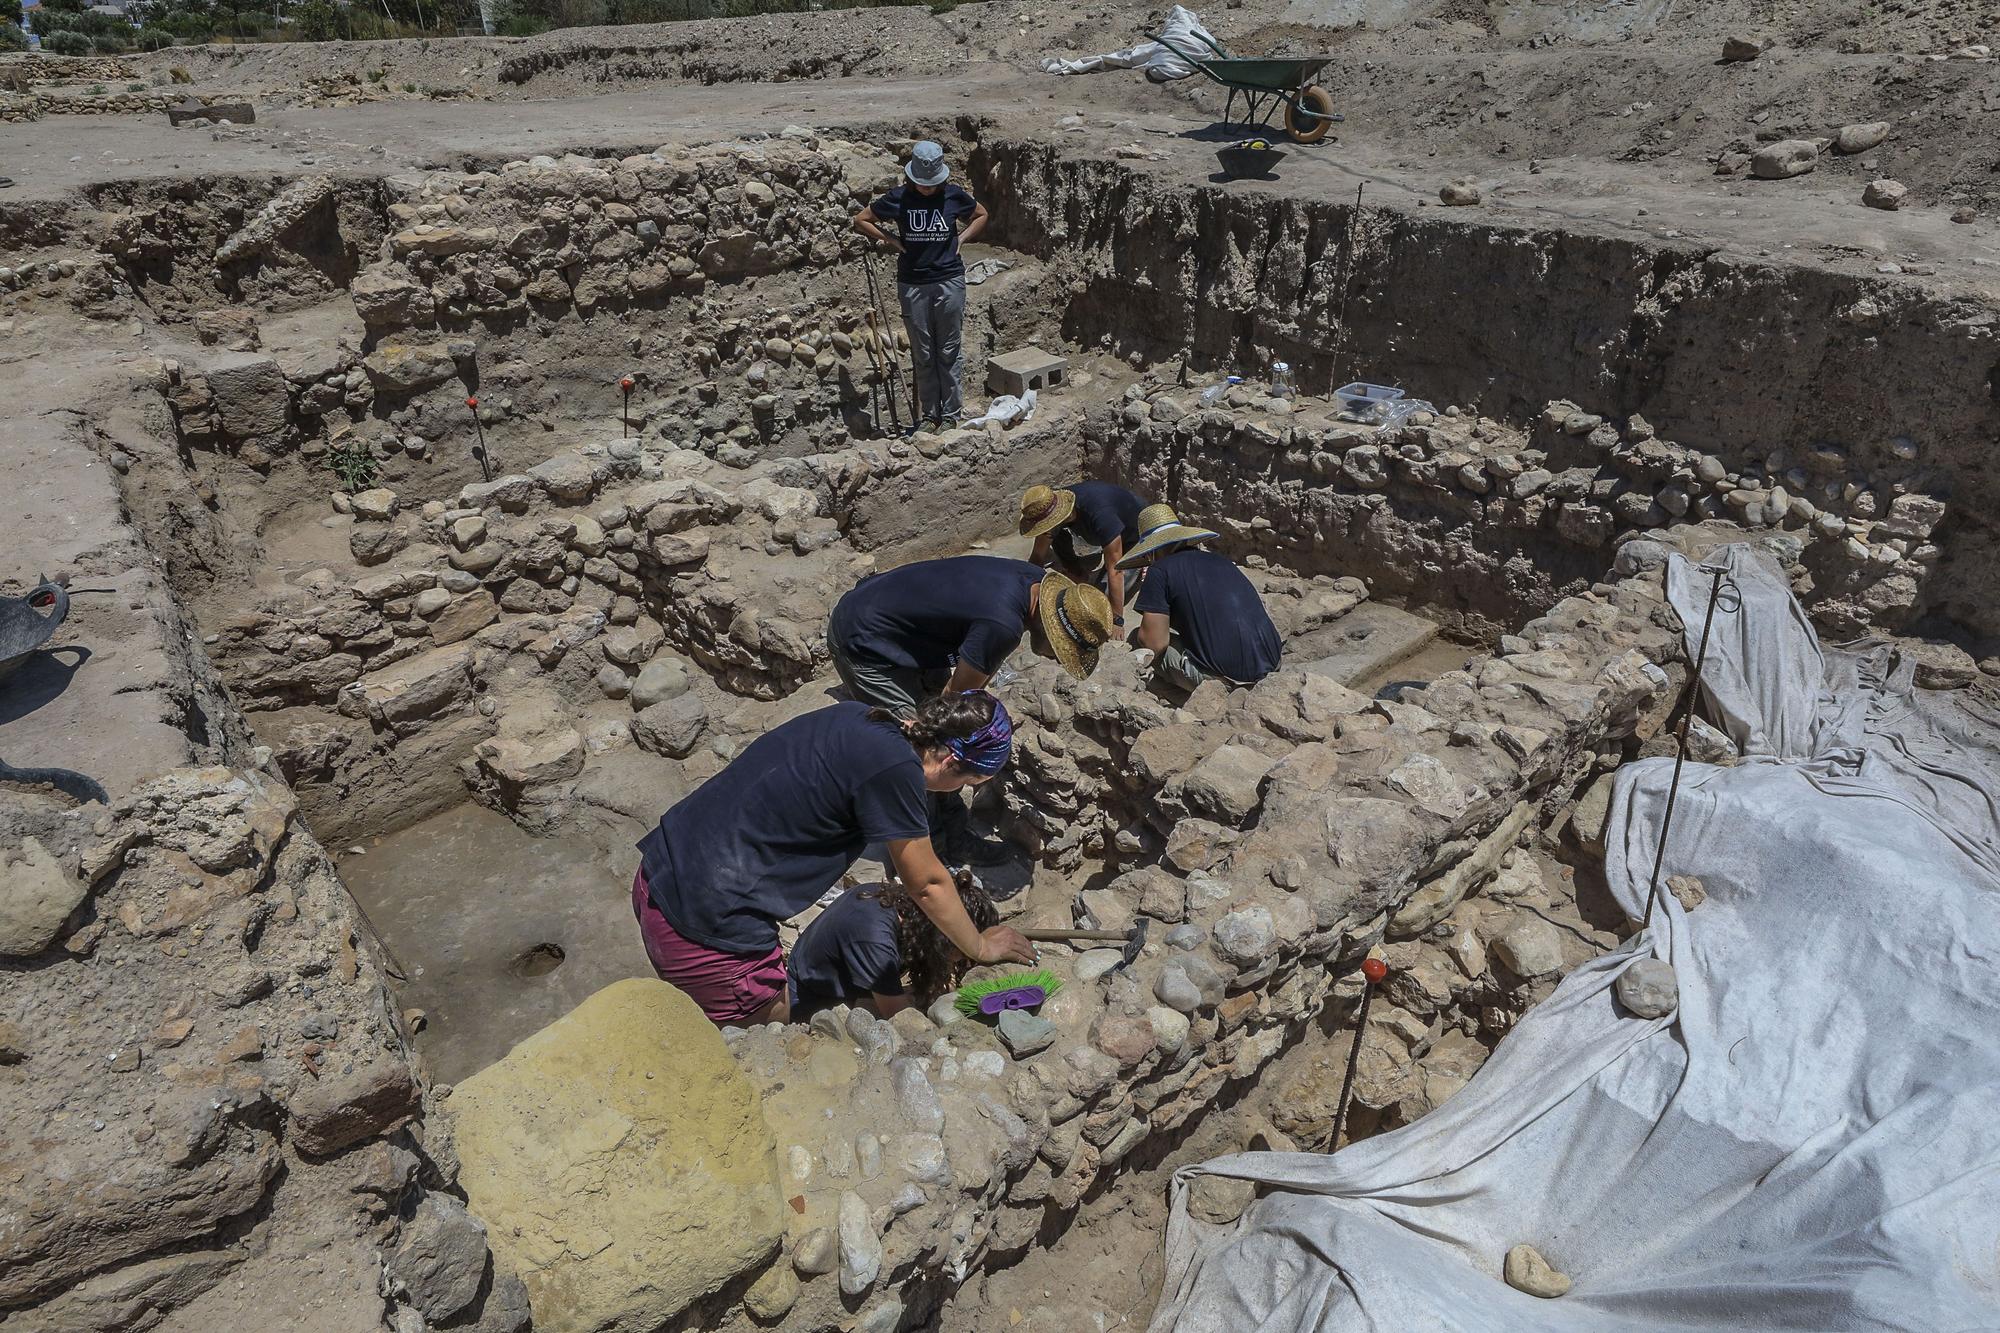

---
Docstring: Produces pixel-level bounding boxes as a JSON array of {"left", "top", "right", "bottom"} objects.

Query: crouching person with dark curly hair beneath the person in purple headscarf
[{"left": 784, "top": 871, "right": 1000, "bottom": 1019}]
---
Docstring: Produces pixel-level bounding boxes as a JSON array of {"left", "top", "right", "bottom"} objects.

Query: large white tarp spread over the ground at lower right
[{"left": 1152, "top": 546, "right": 2000, "bottom": 1333}]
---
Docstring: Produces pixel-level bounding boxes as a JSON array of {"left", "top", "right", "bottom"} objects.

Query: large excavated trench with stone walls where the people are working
[{"left": 31, "top": 126, "right": 2000, "bottom": 1327}]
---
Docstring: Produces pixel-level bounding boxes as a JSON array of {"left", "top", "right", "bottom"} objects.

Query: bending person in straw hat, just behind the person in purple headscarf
[{"left": 826, "top": 556, "right": 1112, "bottom": 865}]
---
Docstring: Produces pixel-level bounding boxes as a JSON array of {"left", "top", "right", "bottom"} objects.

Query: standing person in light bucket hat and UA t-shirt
[{"left": 854, "top": 138, "right": 986, "bottom": 430}]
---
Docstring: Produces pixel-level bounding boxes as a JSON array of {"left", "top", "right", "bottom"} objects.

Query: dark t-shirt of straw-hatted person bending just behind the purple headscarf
[{"left": 826, "top": 556, "right": 1044, "bottom": 675}]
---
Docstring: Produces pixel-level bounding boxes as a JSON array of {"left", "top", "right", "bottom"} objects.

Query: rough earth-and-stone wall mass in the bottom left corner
[{"left": 0, "top": 769, "right": 526, "bottom": 1333}]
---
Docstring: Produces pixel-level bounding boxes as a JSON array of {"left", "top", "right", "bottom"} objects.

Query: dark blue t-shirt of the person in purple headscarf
[{"left": 638, "top": 703, "right": 930, "bottom": 953}]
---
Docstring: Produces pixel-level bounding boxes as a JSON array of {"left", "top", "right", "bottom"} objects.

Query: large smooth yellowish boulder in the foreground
[{"left": 450, "top": 979, "right": 788, "bottom": 1327}]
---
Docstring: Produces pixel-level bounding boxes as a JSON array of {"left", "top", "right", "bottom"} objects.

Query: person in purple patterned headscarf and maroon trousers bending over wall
[{"left": 632, "top": 691, "right": 1034, "bottom": 1025}]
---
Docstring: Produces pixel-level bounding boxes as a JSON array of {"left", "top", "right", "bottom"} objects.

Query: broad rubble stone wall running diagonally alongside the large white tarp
[{"left": 552, "top": 546, "right": 1680, "bottom": 1331}]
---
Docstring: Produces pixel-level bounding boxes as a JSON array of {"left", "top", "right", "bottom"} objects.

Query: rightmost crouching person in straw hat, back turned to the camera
[{"left": 1120, "top": 504, "right": 1278, "bottom": 691}]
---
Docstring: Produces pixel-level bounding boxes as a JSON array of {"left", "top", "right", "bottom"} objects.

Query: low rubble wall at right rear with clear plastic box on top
[{"left": 1084, "top": 386, "right": 1950, "bottom": 636}]
